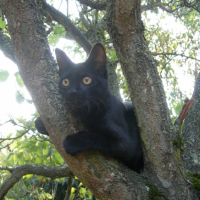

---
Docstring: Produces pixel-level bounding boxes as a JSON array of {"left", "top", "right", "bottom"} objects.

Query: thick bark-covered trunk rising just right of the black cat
[{"left": 107, "top": 0, "right": 195, "bottom": 200}]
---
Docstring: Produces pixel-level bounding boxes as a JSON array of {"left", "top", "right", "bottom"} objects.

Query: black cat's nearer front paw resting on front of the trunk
[{"left": 63, "top": 131, "right": 84, "bottom": 156}]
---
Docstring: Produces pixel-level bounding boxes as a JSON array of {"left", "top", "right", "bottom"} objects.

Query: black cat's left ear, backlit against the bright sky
[{"left": 55, "top": 48, "right": 72, "bottom": 76}]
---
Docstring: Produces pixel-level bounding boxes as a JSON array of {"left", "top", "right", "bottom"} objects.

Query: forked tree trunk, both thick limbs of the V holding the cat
[{"left": 3, "top": 0, "right": 198, "bottom": 200}]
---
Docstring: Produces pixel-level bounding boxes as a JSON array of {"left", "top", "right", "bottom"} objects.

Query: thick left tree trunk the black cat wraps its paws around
[{"left": 4, "top": 0, "right": 148, "bottom": 200}]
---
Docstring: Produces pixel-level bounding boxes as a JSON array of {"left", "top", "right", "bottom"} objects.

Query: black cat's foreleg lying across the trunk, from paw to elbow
[{"left": 63, "top": 131, "right": 132, "bottom": 158}]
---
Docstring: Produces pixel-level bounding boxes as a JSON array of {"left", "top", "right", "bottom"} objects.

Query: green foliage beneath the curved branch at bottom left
[{"left": 1, "top": 175, "right": 98, "bottom": 200}]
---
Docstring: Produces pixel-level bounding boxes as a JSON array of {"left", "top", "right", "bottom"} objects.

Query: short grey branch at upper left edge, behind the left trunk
[{"left": 0, "top": 29, "right": 17, "bottom": 64}]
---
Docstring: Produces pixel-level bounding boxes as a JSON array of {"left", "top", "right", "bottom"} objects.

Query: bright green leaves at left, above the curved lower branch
[{"left": 0, "top": 114, "right": 63, "bottom": 167}]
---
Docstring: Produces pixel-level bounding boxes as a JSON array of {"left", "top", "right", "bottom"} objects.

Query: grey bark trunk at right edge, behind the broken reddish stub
[{"left": 182, "top": 73, "right": 200, "bottom": 173}]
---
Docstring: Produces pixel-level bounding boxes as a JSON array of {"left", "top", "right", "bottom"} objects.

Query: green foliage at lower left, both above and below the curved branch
[{"left": 0, "top": 113, "right": 96, "bottom": 200}]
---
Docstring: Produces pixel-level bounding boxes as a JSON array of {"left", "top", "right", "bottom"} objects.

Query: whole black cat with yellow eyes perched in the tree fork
[{"left": 36, "top": 43, "right": 143, "bottom": 173}]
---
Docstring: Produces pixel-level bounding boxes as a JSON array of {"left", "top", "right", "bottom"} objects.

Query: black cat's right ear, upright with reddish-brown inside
[{"left": 86, "top": 43, "right": 107, "bottom": 76}]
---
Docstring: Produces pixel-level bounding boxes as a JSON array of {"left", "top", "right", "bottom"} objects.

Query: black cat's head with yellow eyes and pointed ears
[{"left": 55, "top": 43, "right": 108, "bottom": 107}]
